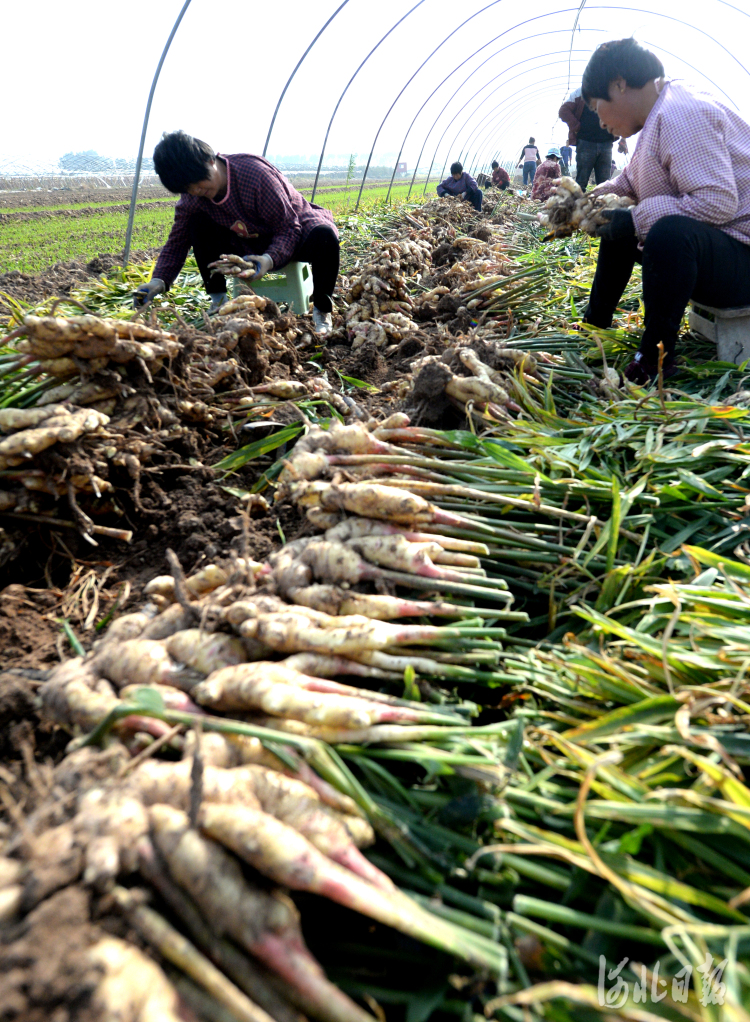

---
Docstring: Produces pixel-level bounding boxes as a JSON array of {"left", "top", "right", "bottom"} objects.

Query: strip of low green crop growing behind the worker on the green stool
[{"left": 0, "top": 182, "right": 434, "bottom": 274}]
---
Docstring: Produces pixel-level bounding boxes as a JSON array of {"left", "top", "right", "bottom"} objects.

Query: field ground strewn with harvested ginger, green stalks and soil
[{"left": 0, "top": 193, "right": 750, "bottom": 1022}]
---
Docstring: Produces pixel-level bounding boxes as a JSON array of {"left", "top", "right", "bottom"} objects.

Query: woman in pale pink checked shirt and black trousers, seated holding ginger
[{"left": 582, "top": 39, "right": 750, "bottom": 383}]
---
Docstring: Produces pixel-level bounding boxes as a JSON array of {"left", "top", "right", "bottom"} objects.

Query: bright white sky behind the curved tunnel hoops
[{"left": 0, "top": 0, "right": 750, "bottom": 174}]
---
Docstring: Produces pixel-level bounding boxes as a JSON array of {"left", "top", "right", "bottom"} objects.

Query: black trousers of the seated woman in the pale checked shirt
[{"left": 585, "top": 216, "right": 750, "bottom": 362}]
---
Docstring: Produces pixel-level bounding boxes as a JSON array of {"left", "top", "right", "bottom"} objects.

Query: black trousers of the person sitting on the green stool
[{"left": 190, "top": 214, "right": 339, "bottom": 313}]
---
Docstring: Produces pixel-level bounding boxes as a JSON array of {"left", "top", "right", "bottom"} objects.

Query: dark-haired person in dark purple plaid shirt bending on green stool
[{"left": 135, "top": 131, "right": 339, "bottom": 335}]
